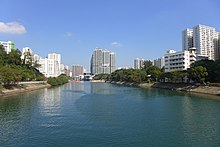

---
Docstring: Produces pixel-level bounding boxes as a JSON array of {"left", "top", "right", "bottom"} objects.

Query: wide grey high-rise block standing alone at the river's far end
[{"left": 90, "top": 48, "right": 115, "bottom": 75}]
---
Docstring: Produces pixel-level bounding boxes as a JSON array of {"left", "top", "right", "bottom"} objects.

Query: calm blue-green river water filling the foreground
[{"left": 0, "top": 82, "right": 220, "bottom": 147}]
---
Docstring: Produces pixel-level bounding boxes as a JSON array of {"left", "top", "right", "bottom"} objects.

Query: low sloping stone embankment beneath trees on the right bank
[{"left": 110, "top": 81, "right": 220, "bottom": 96}]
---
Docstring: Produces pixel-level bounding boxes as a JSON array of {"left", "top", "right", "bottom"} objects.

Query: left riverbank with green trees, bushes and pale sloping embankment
[{"left": 0, "top": 45, "right": 68, "bottom": 96}]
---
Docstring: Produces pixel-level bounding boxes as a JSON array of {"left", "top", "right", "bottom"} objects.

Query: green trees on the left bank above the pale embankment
[{"left": 0, "top": 45, "right": 45, "bottom": 86}]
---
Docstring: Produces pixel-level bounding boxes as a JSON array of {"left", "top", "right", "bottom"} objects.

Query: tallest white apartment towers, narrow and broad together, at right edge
[{"left": 182, "top": 24, "right": 219, "bottom": 60}]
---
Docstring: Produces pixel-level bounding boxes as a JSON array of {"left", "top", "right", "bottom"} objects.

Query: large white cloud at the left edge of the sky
[{"left": 0, "top": 22, "right": 27, "bottom": 34}]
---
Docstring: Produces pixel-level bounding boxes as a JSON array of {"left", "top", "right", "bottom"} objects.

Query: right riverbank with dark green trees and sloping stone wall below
[{"left": 95, "top": 60, "right": 220, "bottom": 95}]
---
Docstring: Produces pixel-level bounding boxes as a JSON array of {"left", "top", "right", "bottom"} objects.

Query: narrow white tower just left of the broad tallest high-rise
[{"left": 182, "top": 29, "right": 193, "bottom": 51}]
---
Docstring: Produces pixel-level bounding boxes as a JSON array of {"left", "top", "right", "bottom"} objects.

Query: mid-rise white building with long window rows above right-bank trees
[{"left": 165, "top": 48, "right": 196, "bottom": 72}]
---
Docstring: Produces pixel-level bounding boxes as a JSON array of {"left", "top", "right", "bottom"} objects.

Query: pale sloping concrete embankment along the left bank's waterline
[{"left": 0, "top": 83, "right": 51, "bottom": 97}]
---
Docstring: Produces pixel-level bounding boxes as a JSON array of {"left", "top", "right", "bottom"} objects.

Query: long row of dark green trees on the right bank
[{"left": 106, "top": 60, "right": 220, "bottom": 84}]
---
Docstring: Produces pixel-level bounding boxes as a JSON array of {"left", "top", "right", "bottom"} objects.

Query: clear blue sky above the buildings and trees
[{"left": 0, "top": 0, "right": 220, "bottom": 70}]
